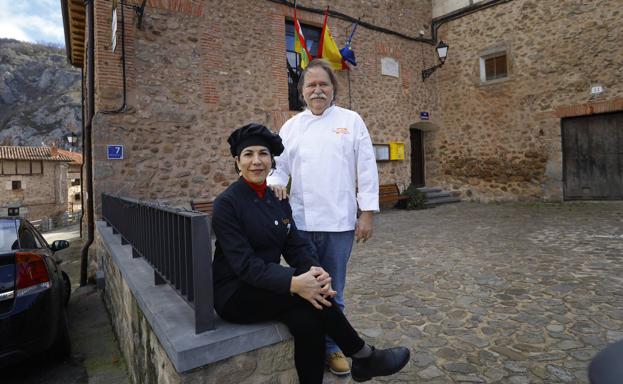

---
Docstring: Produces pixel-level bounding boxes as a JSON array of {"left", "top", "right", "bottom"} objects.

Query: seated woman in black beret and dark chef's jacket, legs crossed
[{"left": 212, "top": 124, "right": 409, "bottom": 384}]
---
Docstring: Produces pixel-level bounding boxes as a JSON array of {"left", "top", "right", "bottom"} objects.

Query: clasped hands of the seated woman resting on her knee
[{"left": 290, "top": 267, "right": 337, "bottom": 309}]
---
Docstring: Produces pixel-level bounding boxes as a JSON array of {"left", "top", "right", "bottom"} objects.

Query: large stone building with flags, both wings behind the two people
[{"left": 61, "top": 0, "right": 623, "bottom": 213}]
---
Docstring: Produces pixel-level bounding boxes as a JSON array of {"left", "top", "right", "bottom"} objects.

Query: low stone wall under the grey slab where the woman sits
[{"left": 94, "top": 231, "right": 298, "bottom": 384}]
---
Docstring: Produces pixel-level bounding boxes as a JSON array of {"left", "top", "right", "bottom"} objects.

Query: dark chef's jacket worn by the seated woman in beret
[{"left": 212, "top": 178, "right": 320, "bottom": 312}]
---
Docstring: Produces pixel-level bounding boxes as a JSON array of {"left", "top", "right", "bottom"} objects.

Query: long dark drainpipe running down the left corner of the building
[{"left": 80, "top": 0, "right": 95, "bottom": 286}]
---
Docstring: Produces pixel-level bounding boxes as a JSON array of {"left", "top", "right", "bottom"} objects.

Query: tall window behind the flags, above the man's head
[{"left": 286, "top": 20, "right": 321, "bottom": 111}]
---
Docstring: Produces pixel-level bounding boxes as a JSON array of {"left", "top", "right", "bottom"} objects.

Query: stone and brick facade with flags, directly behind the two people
[{"left": 88, "top": 0, "right": 439, "bottom": 210}]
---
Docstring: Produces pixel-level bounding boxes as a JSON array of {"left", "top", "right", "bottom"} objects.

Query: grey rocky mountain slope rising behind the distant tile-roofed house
[{"left": 0, "top": 39, "right": 82, "bottom": 148}]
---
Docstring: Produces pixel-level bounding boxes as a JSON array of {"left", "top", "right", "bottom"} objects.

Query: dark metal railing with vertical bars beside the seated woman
[{"left": 102, "top": 193, "right": 214, "bottom": 334}]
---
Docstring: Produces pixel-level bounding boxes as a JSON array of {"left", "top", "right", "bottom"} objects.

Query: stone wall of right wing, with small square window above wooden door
[{"left": 429, "top": 0, "right": 623, "bottom": 201}]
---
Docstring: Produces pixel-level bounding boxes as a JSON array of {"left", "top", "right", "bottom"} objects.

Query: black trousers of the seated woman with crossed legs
[{"left": 219, "top": 285, "right": 364, "bottom": 384}]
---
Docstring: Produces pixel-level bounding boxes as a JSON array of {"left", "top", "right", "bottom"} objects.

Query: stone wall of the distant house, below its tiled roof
[{"left": 0, "top": 161, "right": 67, "bottom": 220}]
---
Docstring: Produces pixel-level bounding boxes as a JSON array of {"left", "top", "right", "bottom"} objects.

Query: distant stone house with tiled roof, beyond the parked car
[{"left": 0, "top": 146, "right": 71, "bottom": 220}]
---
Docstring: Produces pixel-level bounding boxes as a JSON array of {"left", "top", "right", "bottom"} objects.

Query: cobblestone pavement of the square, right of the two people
[{"left": 325, "top": 202, "right": 623, "bottom": 384}]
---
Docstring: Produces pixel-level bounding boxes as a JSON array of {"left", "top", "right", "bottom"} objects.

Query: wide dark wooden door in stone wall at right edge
[{"left": 562, "top": 112, "right": 623, "bottom": 200}]
